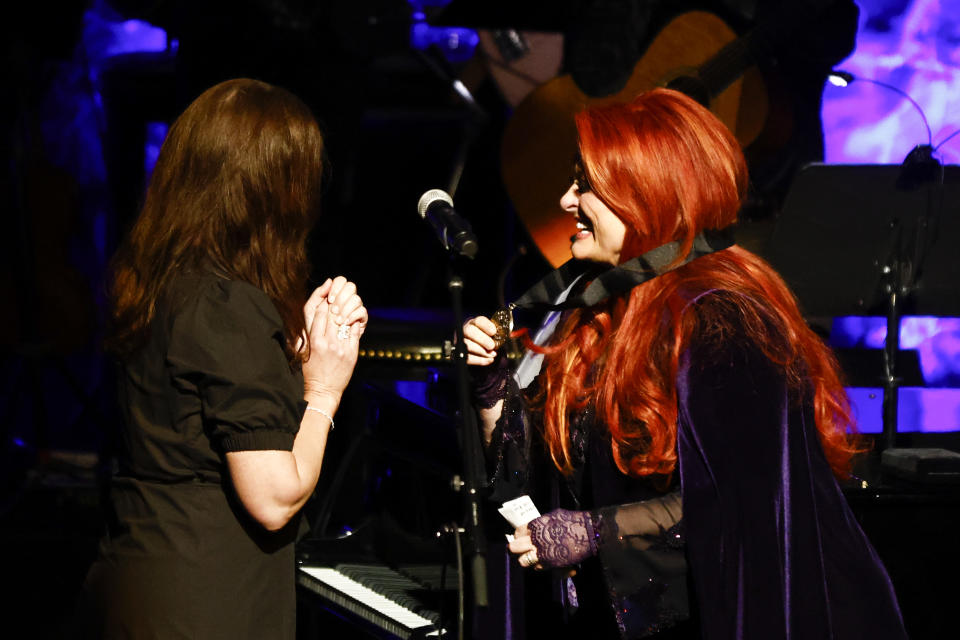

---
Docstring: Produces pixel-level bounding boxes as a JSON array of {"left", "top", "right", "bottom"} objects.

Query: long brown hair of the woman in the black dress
[{"left": 106, "top": 79, "right": 324, "bottom": 361}]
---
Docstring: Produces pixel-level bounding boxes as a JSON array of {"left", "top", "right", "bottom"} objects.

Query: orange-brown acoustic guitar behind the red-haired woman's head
[{"left": 501, "top": 11, "right": 769, "bottom": 267}]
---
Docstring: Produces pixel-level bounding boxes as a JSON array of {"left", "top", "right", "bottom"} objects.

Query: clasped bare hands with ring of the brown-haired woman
[{"left": 303, "top": 276, "right": 368, "bottom": 402}]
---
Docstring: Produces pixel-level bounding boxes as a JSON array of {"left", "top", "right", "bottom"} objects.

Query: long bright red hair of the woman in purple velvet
[{"left": 537, "top": 89, "right": 861, "bottom": 477}]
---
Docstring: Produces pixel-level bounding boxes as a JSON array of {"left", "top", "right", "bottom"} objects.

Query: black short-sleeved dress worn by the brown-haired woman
[{"left": 79, "top": 273, "right": 306, "bottom": 638}]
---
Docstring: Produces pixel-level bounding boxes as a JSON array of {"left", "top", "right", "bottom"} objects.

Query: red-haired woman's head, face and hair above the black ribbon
[{"left": 560, "top": 88, "right": 748, "bottom": 266}]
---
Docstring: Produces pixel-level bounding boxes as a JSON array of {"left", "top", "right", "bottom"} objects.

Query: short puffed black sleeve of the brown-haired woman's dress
[{"left": 167, "top": 276, "right": 306, "bottom": 453}]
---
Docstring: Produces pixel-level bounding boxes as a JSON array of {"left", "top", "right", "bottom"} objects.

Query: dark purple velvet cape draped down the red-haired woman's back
[{"left": 677, "top": 308, "right": 906, "bottom": 639}]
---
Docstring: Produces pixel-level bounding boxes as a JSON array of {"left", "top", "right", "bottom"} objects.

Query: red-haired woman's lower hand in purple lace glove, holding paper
[{"left": 509, "top": 509, "right": 597, "bottom": 569}]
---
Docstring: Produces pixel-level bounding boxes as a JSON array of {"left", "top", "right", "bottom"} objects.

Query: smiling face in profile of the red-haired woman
[{"left": 560, "top": 179, "right": 627, "bottom": 266}]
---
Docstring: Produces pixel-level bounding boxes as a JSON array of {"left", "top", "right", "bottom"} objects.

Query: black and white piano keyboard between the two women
[{"left": 297, "top": 564, "right": 456, "bottom": 639}]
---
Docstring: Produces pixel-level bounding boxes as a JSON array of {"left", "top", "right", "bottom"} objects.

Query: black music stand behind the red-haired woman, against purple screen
[{"left": 766, "top": 164, "right": 960, "bottom": 448}]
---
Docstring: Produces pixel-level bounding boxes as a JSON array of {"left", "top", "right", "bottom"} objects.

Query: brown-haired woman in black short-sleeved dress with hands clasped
[{"left": 76, "top": 79, "right": 367, "bottom": 638}]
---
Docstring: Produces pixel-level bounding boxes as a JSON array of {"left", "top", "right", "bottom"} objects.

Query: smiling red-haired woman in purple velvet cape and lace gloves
[{"left": 464, "top": 89, "right": 905, "bottom": 639}]
